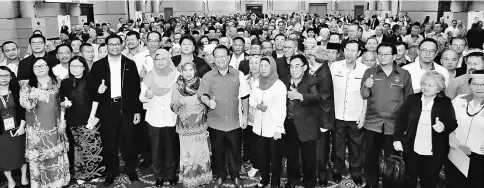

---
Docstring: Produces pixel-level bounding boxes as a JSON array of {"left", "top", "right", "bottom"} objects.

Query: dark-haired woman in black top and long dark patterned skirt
[{"left": 59, "top": 56, "right": 105, "bottom": 180}]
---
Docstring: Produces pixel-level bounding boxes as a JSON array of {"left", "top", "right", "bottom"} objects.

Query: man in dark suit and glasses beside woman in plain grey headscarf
[{"left": 284, "top": 54, "right": 321, "bottom": 188}]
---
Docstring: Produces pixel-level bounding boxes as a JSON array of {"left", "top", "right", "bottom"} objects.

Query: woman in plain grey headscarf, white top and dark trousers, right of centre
[{"left": 249, "top": 56, "right": 287, "bottom": 188}]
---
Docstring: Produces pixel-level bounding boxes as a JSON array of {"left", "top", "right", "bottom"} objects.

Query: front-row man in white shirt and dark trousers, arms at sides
[{"left": 331, "top": 41, "right": 368, "bottom": 185}]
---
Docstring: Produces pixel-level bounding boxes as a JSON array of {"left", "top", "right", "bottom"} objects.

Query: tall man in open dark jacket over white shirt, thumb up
[{"left": 89, "top": 35, "right": 142, "bottom": 186}]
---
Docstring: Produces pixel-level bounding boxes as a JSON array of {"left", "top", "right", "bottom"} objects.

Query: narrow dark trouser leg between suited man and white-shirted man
[{"left": 317, "top": 131, "right": 331, "bottom": 180}]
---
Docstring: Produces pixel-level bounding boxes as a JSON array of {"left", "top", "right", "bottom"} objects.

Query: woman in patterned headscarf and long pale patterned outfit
[{"left": 171, "top": 62, "right": 212, "bottom": 188}]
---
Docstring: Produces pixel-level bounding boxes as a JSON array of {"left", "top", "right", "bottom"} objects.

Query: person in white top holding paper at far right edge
[{"left": 445, "top": 70, "right": 484, "bottom": 188}]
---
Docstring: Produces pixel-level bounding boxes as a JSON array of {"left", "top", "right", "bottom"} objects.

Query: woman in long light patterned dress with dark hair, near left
[{"left": 20, "top": 57, "right": 70, "bottom": 188}]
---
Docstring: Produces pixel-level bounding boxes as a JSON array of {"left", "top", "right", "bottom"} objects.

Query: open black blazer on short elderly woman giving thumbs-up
[{"left": 394, "top": 92, "right": 457, "bottom": 157}]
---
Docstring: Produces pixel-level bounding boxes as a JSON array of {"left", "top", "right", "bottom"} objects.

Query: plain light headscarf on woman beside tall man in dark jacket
[{"left": 143, "top": 49, "right": 177, "bottom": 96}]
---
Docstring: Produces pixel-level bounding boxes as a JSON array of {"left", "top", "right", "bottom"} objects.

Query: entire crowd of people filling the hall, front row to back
[{"left": 0, "top": 13, "right": 484, "bottom": 188}]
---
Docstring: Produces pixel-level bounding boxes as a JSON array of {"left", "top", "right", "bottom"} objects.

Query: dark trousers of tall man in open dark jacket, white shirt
[{"left": 99, "top": 102, "right": 138, "bottom": 175}]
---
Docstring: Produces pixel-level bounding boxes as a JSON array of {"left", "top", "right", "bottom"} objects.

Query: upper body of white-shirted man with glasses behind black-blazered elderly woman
[{"left": 402, "top": 38, "right": 449, "bottom": 93}]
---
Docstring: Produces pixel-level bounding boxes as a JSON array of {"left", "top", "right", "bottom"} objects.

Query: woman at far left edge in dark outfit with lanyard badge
[{"left": 0, "top": 66, "right": 29, "bottom": 188}]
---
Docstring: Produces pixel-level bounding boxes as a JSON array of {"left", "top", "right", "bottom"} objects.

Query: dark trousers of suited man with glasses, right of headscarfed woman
[{"left": 284, "top": 121, "right": 318, "bottom": 188}]
